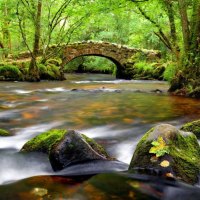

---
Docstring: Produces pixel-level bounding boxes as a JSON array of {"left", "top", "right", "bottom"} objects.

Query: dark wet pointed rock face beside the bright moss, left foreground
[{"left": 49, "top": 130, "right": 111, "bottom": 171}]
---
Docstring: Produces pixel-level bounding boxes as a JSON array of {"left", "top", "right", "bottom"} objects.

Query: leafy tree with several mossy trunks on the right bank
[{"left": 132, "top": 0, "right": 200, "bottom": 96}]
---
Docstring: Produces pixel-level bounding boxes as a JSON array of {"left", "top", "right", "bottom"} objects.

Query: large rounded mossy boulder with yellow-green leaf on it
[{"left": 129, "top": 124, "right": 200, "bottom": 184}]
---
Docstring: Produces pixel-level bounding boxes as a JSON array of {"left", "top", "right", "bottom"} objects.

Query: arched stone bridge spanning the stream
[{"left": 62, "top": 41, "right": 159, "bottom": 79}]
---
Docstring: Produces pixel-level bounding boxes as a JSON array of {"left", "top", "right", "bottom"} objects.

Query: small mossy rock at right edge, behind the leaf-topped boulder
[{"left": 181, "top": 120, "right": 200, "bottom": 139}]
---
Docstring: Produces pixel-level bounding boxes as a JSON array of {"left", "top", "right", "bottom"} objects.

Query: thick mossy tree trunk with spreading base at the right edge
[{"left": 170, "top": 0, "right": 200, "bottom": 97}]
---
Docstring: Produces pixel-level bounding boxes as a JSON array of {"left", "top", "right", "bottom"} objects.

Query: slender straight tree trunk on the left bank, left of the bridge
[{"left": 28, "top": 0, "right": 42, "bottom": 81}]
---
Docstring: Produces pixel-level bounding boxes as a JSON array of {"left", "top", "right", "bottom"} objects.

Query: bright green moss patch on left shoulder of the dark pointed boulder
[{"left": 21, "top": 129, "right": 67, "bottom": 154}]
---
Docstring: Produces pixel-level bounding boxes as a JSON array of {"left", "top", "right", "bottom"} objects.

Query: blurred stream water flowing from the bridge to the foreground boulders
[{"left": 0, "top": 74, "right": 200, "bottom": 198}]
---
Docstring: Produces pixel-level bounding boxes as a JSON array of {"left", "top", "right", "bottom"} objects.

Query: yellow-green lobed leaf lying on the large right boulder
[{"left": 149, "top": 136, "right": 170, "bottom": 157}]
